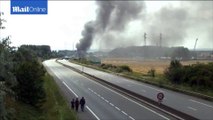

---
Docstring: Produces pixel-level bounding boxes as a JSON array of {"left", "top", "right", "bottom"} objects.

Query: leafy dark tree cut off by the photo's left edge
[{"left": 0, "top": 12, "right": 16, "bottom": 120}]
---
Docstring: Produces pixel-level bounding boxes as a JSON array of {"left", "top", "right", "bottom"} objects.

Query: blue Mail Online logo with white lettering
[{"left": 10, "top": 0, "right": 47, "bottom": 14}]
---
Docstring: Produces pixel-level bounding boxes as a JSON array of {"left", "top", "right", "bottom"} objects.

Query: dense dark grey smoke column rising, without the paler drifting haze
[{"left": 76, "top": 1, "right": 143, "bottom": 51}]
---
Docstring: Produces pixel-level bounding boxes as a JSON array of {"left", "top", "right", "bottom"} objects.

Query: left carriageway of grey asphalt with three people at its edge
[{"left": 43, "top": 60, "right": 175, "bottom": 120}]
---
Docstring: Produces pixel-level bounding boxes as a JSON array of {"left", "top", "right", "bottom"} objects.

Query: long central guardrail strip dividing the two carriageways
[{"left": 56, "top": 60, "right": 198, "bottom": 120}]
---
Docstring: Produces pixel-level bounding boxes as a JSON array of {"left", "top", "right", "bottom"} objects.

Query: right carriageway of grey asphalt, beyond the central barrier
[{"left": 59, "top": 60, "right": 213, "bottom": 120}]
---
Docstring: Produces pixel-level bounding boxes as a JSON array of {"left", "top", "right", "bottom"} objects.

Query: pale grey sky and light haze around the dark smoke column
[{"left": 0, "top": 1, "right": 213, "bottom": 50}]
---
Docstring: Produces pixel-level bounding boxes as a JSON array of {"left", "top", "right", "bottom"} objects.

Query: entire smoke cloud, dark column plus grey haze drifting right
[{"left": 76, "top": 0, "right": 213, "bottom": 51}]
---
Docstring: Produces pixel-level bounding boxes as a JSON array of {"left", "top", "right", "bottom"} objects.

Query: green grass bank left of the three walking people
[{"left": 5, "top": 73, "right": 77, "bottom": 120}]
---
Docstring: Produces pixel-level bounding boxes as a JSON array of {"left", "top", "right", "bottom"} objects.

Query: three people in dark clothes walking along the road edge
[{"left": 71, "top": 97, "right": 86, "bottom": 112}]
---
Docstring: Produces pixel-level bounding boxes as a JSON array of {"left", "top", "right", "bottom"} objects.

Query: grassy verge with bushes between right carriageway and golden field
[{"left": 70, "top": 60, "right": 213, "bottom": 101}]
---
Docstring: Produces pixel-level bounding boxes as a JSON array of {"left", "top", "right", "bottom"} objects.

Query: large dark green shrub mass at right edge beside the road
[{"left": 165, "top": 60, "right": 213, "bottom": 89}]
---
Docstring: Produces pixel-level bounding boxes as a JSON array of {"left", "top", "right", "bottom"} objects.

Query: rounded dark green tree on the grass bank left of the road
[{"left": 15, "top": 60, "right": 45, "bottom": 107}]
